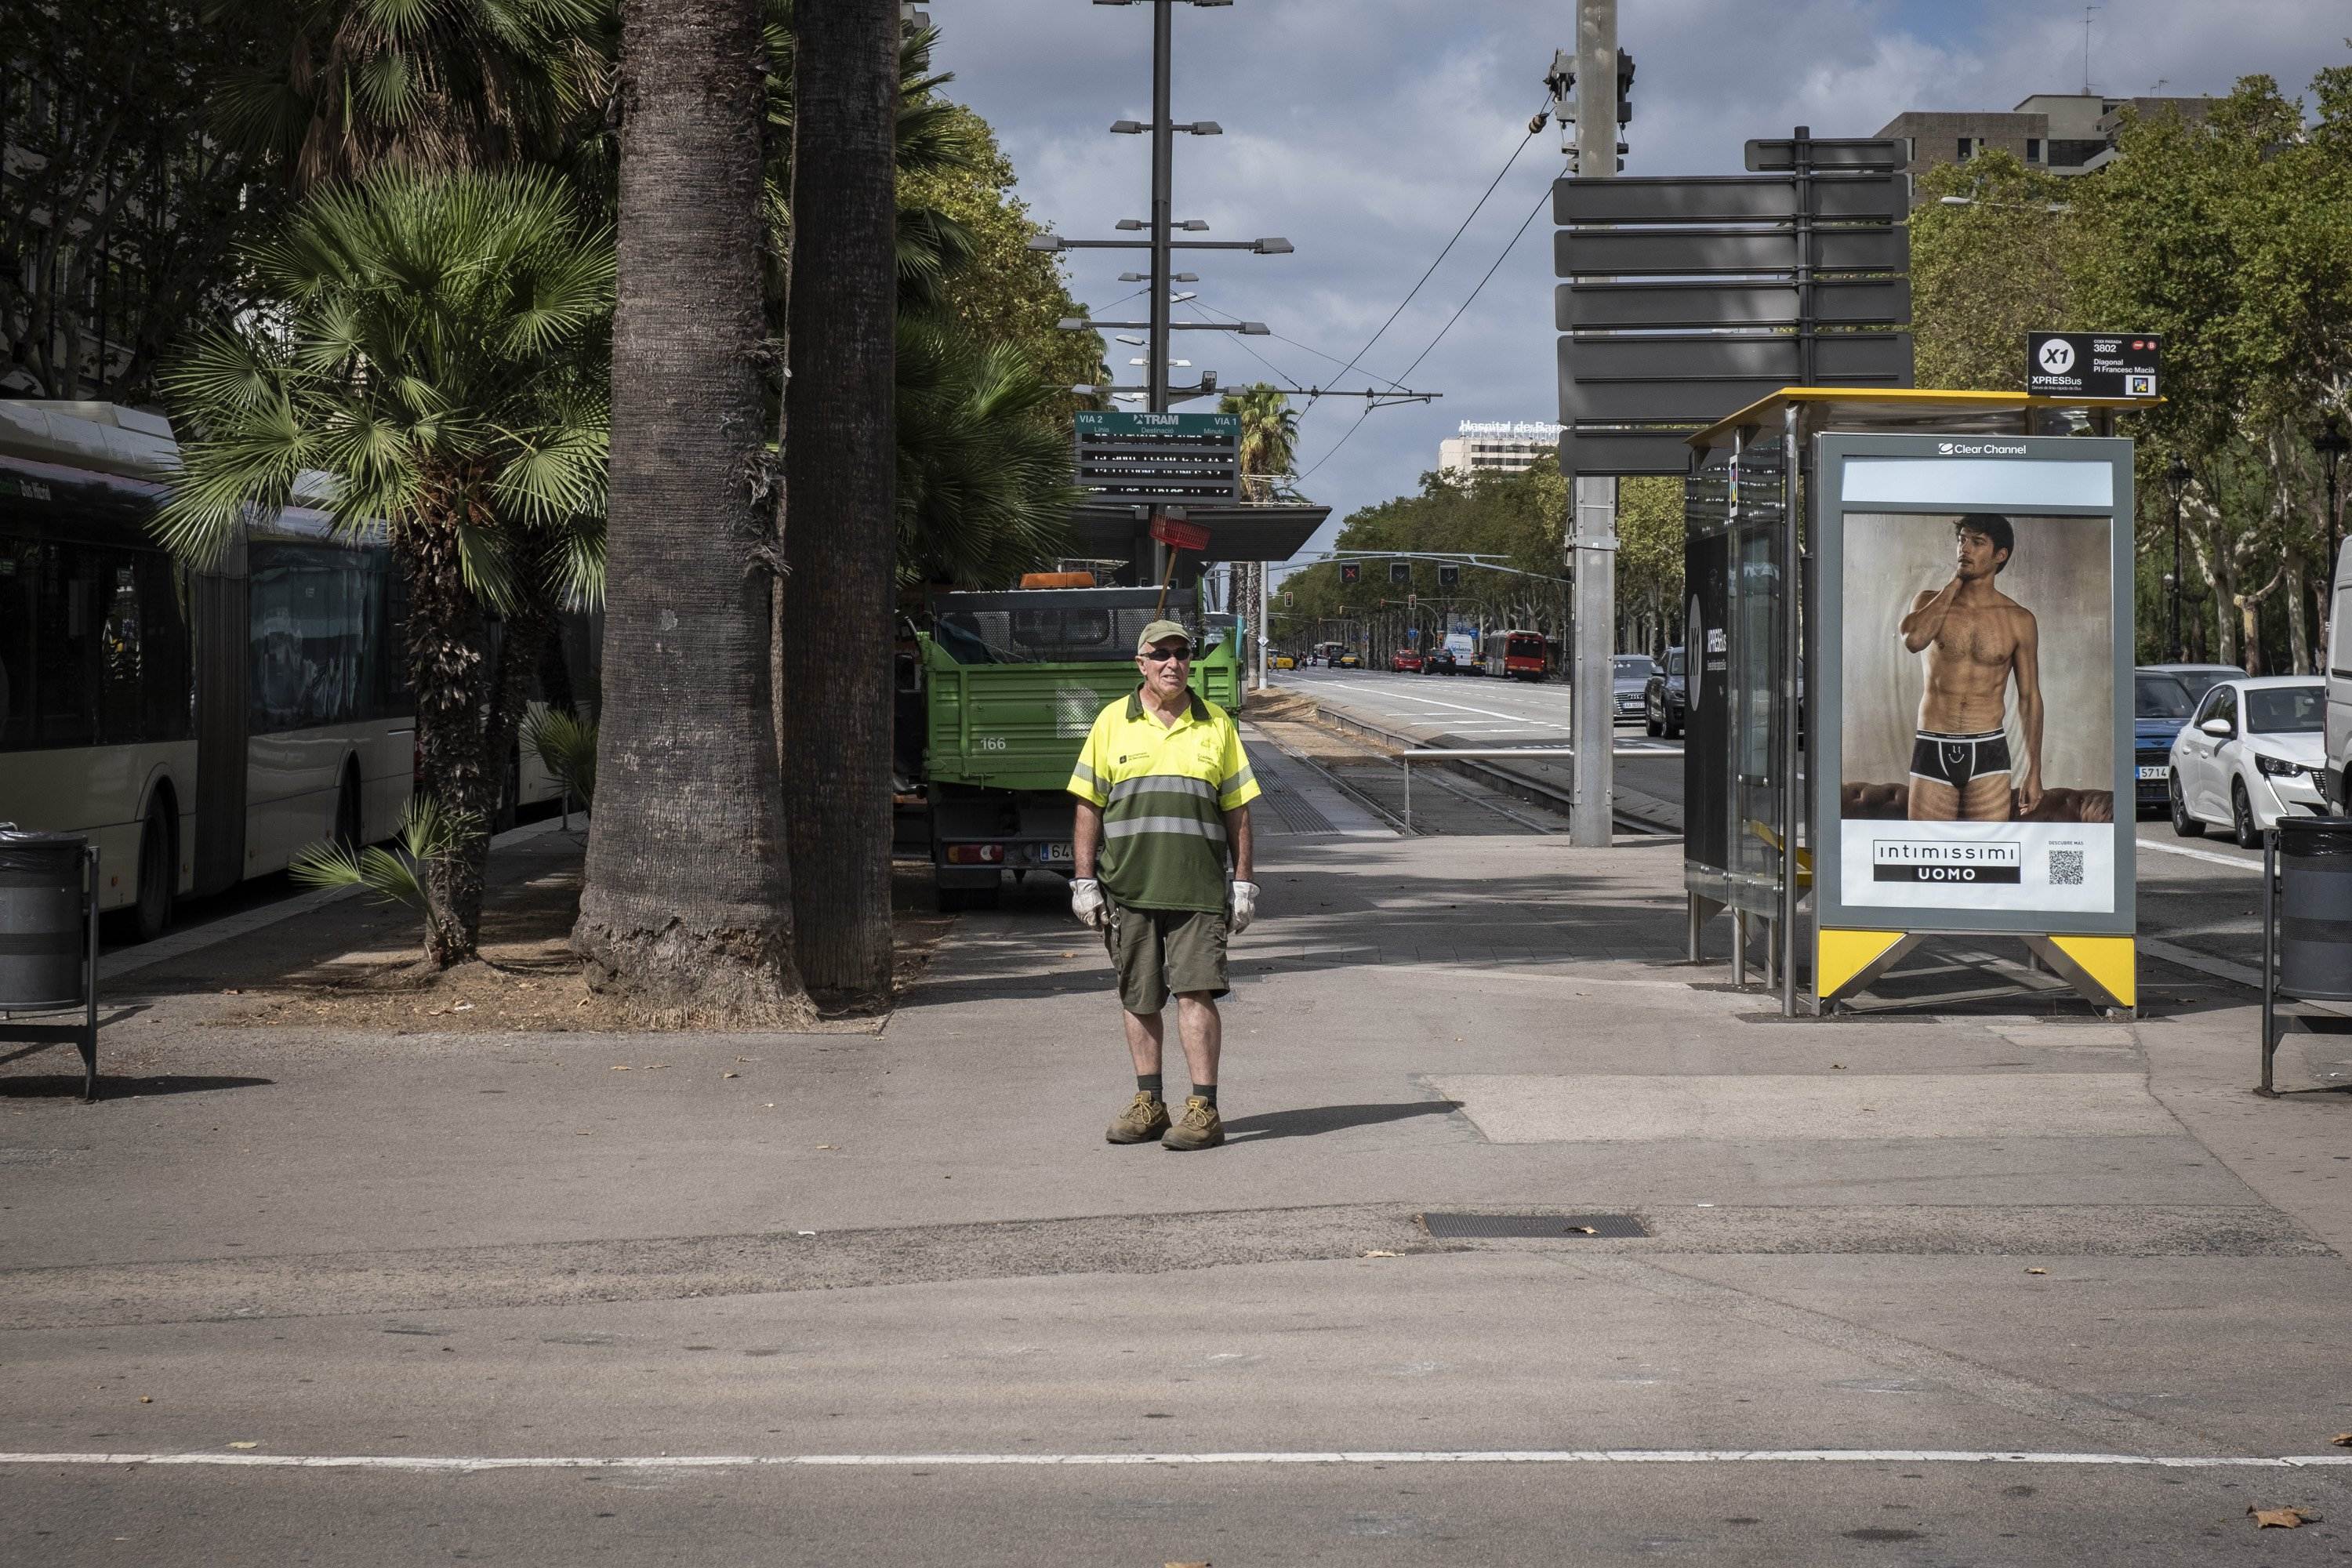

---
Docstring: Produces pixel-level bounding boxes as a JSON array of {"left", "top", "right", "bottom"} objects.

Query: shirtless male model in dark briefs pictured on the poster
[{"left": 1903, "top": 513, "right": 2042, "bottom": 822}]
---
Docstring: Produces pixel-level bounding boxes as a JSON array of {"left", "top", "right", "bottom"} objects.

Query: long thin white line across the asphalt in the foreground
[{"left": 0, "top": 1448, "right": 2352, "bottom": 1474}]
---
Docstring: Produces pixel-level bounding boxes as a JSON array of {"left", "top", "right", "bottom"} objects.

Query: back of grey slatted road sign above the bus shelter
[{"left": 1552, "top": 127, "right": 1912, "bottom": 475}]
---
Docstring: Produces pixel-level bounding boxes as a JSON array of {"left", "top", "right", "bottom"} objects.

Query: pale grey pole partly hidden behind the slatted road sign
[{"left": 1569, "top": 0, "right": 1618, "bottom": 848}]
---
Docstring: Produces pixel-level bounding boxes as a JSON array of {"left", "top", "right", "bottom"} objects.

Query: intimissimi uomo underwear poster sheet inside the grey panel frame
[{"left": 1839, "top": 510, "right": 2114, "bottom": 914}]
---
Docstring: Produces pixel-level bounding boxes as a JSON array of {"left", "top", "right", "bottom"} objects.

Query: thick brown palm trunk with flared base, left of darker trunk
[{"left": 572, "top": 0, "right": 811, "bottom": 1027}]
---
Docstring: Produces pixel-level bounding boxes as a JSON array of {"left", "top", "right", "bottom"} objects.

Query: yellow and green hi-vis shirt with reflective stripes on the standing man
[{"left": 1070, "top": 689, "right": 1258, "bottom": 912}]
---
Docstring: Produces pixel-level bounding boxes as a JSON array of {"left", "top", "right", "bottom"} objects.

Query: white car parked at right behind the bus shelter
[{"left": 2171, "top": 675, "right": 2328, "bottom": 848}]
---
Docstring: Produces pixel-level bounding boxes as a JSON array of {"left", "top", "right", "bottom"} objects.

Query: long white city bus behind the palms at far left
[{"left": 0, "top": 402, "right": 588, "bottom": 935}]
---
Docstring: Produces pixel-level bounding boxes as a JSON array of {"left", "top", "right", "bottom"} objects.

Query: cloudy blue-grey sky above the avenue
[{"left": 924, "top": 0, "right": 2352, "bottom": 564}]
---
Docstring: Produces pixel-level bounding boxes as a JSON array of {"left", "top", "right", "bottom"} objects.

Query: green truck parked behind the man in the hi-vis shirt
[{"left": 898, "top": 588, "right": 1242, "bottom": 909}]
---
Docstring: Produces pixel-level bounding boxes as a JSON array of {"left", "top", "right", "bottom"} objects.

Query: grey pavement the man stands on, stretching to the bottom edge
[{"left": 0, "top": 822, "right": 2352, "bottom": 1563}]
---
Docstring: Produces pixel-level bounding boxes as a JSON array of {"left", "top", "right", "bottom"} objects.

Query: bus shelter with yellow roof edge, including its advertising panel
[{"left": 1684, "top": 388, "right": 2147, "bottom": 1015}]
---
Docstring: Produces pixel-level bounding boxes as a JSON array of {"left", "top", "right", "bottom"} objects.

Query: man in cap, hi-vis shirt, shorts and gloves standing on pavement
[{"left": 1070, "top": 621, "right": 1258, "bottom": 1149}]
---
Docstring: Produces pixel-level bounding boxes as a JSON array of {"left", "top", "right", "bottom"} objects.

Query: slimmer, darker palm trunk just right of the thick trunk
[{"left": 783, "top": 0, "right": 898, "bottom": 996}]
